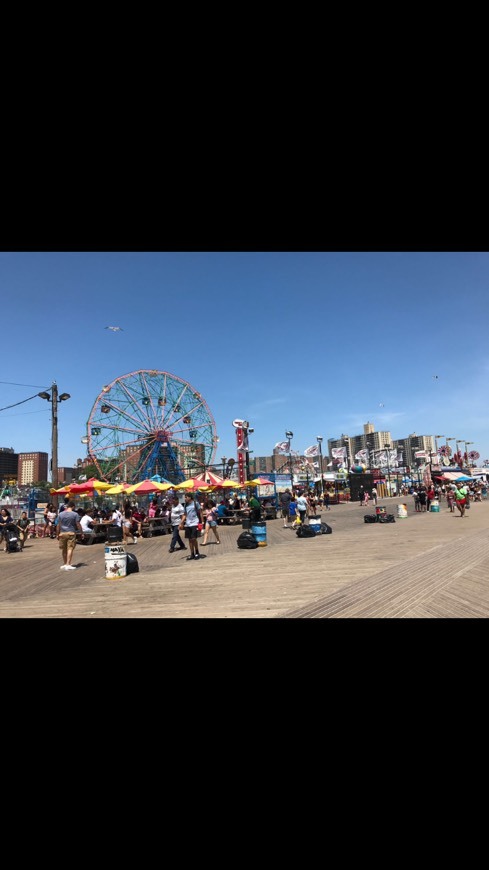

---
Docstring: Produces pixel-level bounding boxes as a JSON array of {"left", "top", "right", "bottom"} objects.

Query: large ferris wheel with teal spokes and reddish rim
[{"left": 86, "top": 369, "right": 219, "bottom": 483}]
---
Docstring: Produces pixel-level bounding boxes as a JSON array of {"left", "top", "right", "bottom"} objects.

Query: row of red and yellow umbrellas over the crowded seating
[{"left": 50, "top": 472, "right": 270, "bottom": 495}]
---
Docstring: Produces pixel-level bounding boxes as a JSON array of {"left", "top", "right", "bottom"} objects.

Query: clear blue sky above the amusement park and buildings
[{"left": 0, "top": 252, "right": 489, "bottom": 466}]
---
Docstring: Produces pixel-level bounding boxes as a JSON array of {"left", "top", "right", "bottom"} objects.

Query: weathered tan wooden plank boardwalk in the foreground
[{"left": 0, "top": 498, "right": 489, "bottom": 619}]
